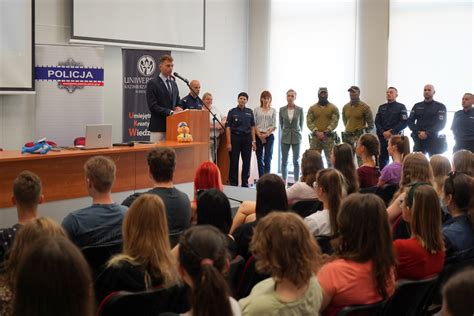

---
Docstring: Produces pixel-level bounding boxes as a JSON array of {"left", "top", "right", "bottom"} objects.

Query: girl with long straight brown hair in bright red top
[{"left": 393, "top": 183, "right": 445, "bottom": 280}]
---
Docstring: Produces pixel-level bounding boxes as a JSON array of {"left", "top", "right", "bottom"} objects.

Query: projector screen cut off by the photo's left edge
[{"left": 0, "top": 0, "right": 34, "bottom": 94}]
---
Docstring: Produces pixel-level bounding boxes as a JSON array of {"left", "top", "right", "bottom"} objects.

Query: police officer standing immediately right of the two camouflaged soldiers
[{"left": 375, "top": 87, "right": 408, "bottom": 170}]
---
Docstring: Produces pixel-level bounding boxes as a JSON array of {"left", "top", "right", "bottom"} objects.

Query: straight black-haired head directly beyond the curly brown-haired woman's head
[{"left": 255, "top": 173, "right": 288, "bottom": 219}]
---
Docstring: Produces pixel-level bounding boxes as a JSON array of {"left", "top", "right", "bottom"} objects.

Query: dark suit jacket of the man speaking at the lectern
[{"left": 146, "top": 76, "right": 180, "bottom": 132}]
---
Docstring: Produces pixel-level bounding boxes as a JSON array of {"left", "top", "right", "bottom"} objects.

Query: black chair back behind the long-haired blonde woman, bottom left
[{"left": 97, "top": 286, "right": 190, "bottom": 316}]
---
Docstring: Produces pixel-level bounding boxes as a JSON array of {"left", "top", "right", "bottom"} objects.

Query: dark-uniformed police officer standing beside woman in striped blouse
[{"left": 226, "top": 92, "right": 256, "bottom": 187}]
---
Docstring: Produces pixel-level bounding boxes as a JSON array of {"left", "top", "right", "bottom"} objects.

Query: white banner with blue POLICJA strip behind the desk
[{"left": 32, "top": 45, "right": 104, "bottom": 146}]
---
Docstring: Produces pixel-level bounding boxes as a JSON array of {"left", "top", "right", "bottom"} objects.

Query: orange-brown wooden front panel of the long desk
[{"left": 0, "top": 141, "right": 209, "bottom": 208}]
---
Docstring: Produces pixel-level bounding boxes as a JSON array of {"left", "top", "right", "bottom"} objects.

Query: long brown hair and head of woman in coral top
[{"left": 334, "top": 193, "right": 395, "bottom": 298}]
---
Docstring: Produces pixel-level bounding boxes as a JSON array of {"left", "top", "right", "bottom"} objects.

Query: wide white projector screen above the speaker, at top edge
[{"left": 71, "top": 0, "right": 206, "bottom": 50}]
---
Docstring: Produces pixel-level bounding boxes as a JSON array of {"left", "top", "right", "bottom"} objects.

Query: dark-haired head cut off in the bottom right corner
[{"left": 441, "top": 267, "right": 474, "bottom": 316}]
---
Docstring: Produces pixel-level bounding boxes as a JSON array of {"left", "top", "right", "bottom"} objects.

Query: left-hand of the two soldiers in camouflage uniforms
[{"left": 306, "top": 88, "right": 339, "bottom": 167}]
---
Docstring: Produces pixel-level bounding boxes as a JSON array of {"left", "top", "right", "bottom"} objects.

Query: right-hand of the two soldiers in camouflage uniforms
[{"left": 342, "top": 86, "right": 374, "bottom": 165}]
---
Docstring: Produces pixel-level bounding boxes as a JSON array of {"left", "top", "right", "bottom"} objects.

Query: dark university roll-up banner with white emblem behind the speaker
[{"left": 122, "top": 49, "right": 171, "bottom": 142}]
